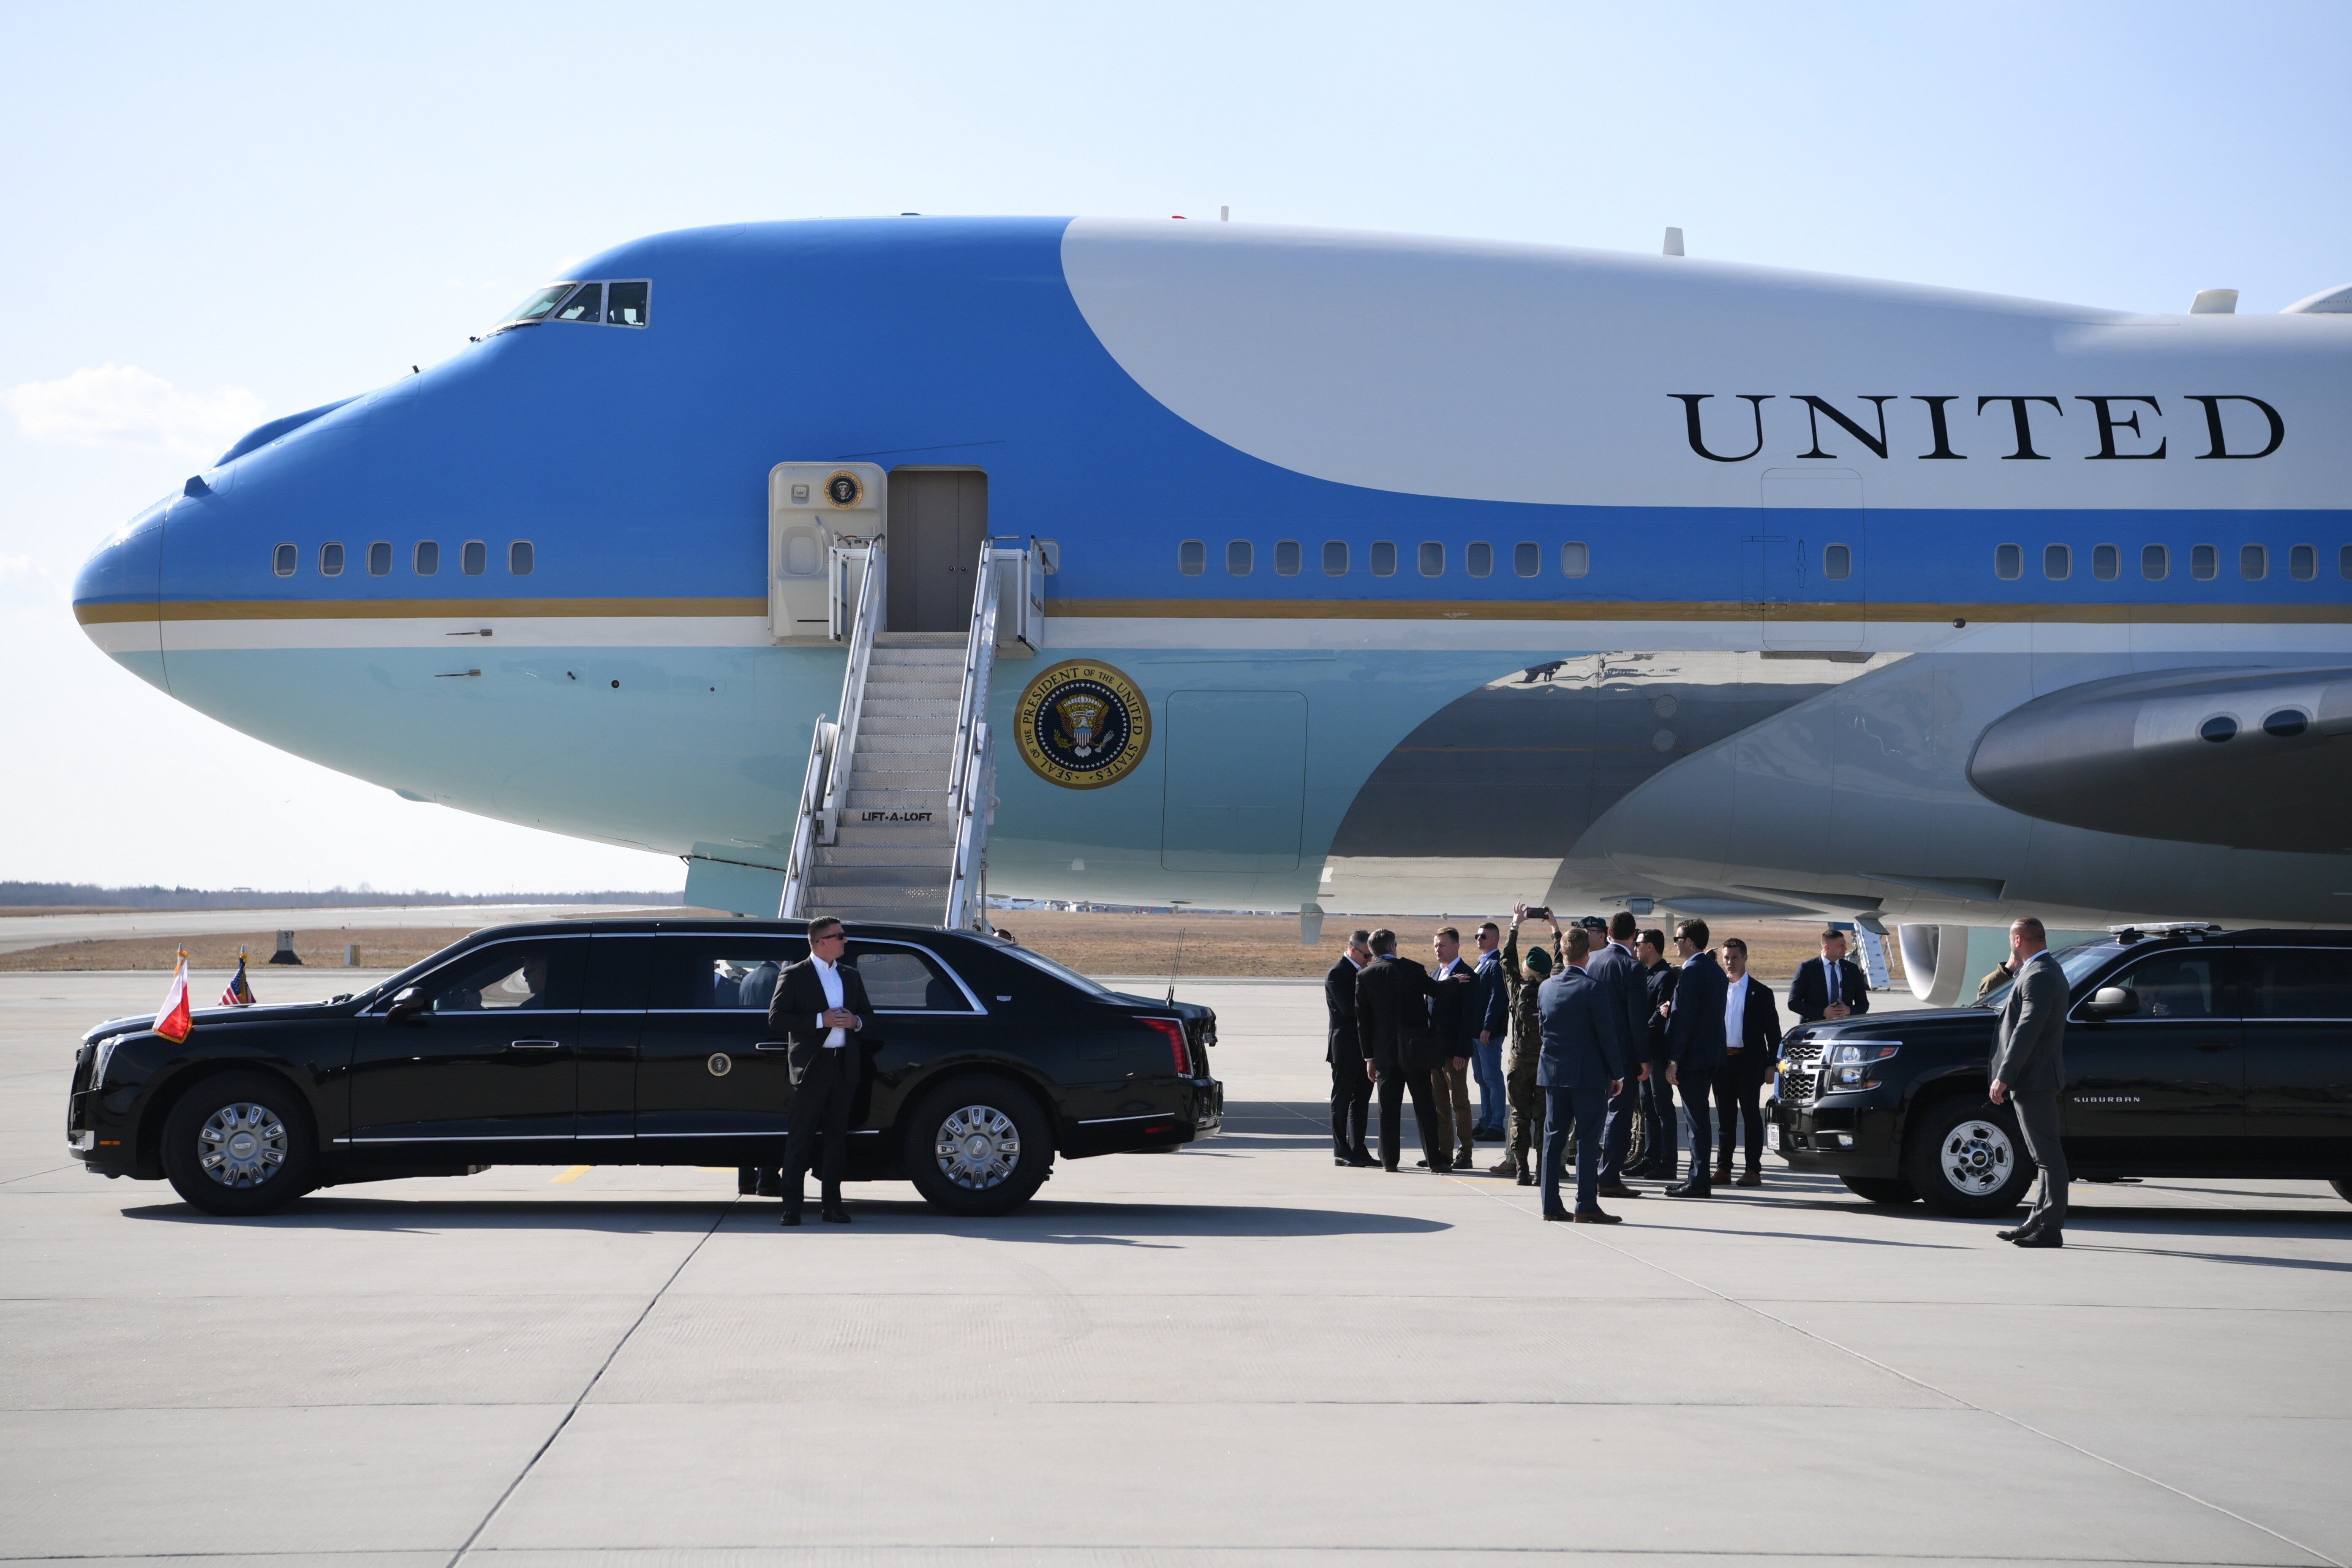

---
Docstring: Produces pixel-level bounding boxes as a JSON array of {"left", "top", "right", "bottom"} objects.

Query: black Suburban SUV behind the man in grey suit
[{"left": 1773, "top": 926, "right": 2352, "bottom": 1215}]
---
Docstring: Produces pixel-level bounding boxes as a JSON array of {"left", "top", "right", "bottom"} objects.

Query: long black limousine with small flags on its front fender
[{"left": 66, "top": 919, "right": 1225, "bottom": 1215}]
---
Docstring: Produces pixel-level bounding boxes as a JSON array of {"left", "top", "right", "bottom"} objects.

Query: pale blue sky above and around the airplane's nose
[{"left": 0, "top": 0, "right": 2352, "bottom": 891}]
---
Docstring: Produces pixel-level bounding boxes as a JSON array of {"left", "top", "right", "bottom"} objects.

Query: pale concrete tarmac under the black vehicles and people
[{"left": 0, "top": 971, "right": 2352, "bottom": 1568}]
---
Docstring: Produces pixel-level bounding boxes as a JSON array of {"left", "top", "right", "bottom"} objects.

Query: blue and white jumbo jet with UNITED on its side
[{"left": 75, "top": 216, "right": 2352, "bottom": 992}]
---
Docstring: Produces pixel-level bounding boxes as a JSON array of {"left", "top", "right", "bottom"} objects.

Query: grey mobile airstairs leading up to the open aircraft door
[{"left": 779, "top": 536, "right": 1044, "bottom": 928}]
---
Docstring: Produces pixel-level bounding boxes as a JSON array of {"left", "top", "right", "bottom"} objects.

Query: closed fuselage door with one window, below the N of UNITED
[{"left": 1740, "top": 468, "right": 1870, "bottom": 651}]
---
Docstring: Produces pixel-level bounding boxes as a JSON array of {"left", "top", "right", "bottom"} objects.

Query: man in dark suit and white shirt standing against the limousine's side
[{"left": 767, "top": 917, "right": 882, "bottom": 1225}]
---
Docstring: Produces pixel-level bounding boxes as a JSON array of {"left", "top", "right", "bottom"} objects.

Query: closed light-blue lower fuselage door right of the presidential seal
[{"left": 1160, "top": 691, "right": 1308, "bottom": 874}]
